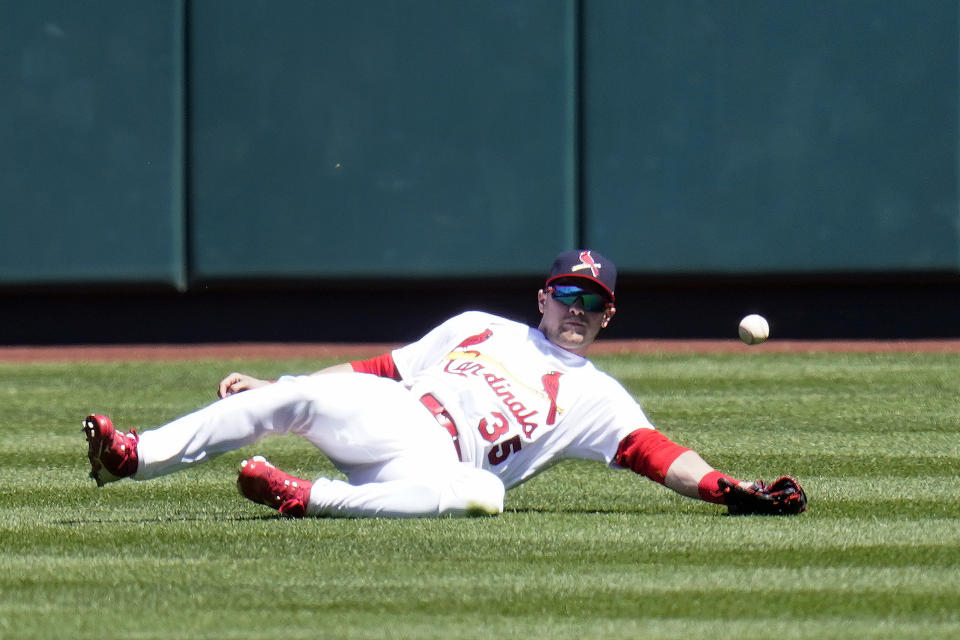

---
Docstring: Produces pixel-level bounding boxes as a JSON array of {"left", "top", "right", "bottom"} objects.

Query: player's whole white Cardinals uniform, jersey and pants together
[{"left": 135, "top": 311, "right": 652, "bottom": 516}]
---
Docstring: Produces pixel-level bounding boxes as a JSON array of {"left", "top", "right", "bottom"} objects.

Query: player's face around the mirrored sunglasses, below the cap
[{"left": 537, "top": 281, "right": 616, "bottom": 355}]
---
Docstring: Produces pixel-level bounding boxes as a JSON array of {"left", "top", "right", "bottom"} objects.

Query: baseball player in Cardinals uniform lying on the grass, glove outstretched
[{"left": 84, "top": 250, "right": 806, "bottom": 517}]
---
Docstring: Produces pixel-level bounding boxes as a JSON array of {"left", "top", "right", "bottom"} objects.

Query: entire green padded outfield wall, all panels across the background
[{"left": 0, "top": 0, "right": 960, "bottom": 290}]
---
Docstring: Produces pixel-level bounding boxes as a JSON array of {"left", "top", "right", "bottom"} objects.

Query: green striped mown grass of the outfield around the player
[{"left": 0, "top": 352, "right": 960, "bottom": 640}]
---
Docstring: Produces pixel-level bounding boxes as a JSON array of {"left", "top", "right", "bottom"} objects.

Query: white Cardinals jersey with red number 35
[{"left": 392, "top": 311, "right": 652, "bottom": 488}]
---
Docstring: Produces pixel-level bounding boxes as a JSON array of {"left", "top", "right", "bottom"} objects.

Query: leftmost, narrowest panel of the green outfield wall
[{"left": 0, "top": 0, "right": 187, "bottom": 286}]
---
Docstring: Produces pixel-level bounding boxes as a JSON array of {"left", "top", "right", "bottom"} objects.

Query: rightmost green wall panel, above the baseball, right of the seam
[{"left": 580, "top": 0, "right": 960, "bottom": 273}]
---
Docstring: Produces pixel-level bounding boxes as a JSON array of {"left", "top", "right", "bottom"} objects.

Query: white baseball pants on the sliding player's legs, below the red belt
[{"left": 134, "top": 373, "right": 504, "bottom": 517}]
